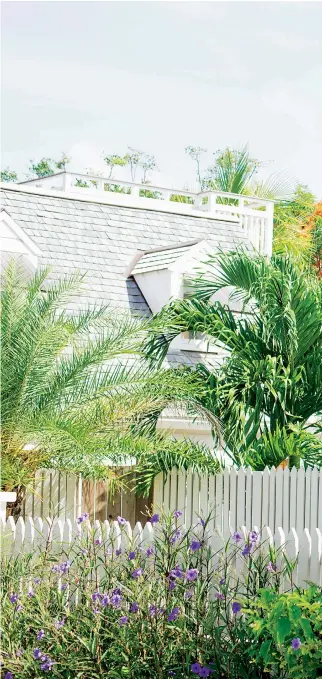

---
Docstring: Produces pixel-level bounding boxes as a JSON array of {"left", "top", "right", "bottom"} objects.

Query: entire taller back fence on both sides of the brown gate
[{"left": 23, "top": 467, "right": 322, "bottom": 539}]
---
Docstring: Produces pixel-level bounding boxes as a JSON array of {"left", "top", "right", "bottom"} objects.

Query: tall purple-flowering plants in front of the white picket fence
[{"left": 1, "top": 512, "right": 306, "bottom": 679}]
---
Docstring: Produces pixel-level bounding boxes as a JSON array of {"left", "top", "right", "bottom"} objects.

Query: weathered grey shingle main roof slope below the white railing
[{"left": 1, "top": 186, "right": 246, "bottom": 361}]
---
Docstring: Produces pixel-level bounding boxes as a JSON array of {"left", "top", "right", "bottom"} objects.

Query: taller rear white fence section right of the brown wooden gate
[{"left": 153, "top": 467, "right": 322, "bottom": 535}]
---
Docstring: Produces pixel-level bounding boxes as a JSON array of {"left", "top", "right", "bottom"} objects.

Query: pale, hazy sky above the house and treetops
[{"left": 1, "top": 0, "right": 322, "bottom": 197}]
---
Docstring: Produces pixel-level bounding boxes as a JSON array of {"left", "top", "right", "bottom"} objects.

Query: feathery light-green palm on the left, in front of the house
[{"left": 1, "top": 261, "right": 218, "bottom": 503}]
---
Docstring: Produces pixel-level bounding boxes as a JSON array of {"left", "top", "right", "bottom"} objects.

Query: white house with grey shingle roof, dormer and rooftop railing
[{"left": 0, "top": 172, "right": 273, "bottom": 520}]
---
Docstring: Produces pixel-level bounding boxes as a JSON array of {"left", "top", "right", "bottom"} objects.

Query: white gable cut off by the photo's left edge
[{"left": 0, "top": 210, "right": 41, "bottom": 271}]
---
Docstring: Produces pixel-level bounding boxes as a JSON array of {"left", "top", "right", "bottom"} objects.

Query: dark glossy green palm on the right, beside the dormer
[{"left": 146, "top": 251, "right": 322, "bottom": 468}]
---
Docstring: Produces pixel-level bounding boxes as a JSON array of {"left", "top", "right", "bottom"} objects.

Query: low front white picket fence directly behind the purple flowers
[{"left": 0, "top": 517, "right": 322, "bottom": 589}]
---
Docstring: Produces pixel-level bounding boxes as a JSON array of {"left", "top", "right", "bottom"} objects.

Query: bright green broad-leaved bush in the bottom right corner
[{"left": 247, "top": 586, "right": 322, "bottom": 679}]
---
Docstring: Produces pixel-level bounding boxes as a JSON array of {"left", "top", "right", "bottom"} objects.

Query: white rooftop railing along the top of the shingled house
[{"left": 21, "top": 172, "right": 274, "bottom": 255}]
